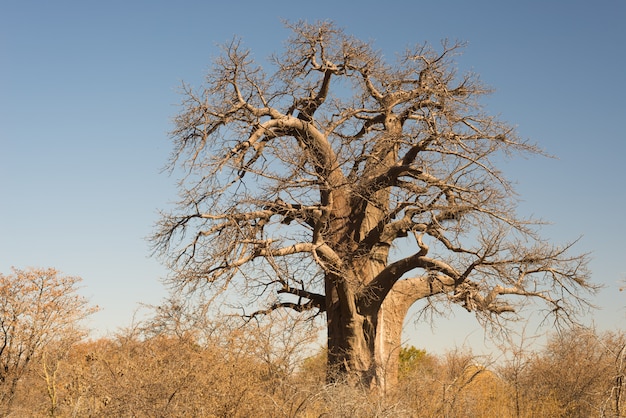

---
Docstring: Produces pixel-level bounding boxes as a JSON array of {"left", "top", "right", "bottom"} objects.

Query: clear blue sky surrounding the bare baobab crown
[{"left": 0, "top": 0, "right": 626, "bottom": 351}]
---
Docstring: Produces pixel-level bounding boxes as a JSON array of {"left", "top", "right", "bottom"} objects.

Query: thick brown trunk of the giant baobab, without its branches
[{"left": 325, "top": 162, "right": 415, "bottom": 391}]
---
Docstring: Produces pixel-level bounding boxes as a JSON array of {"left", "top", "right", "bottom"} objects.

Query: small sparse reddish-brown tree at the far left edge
[{"left": 0, "top": 268, "right": 96, "bottom": 416}]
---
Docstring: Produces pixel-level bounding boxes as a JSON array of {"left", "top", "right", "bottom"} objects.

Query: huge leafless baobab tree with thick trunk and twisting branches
[{"left": 153, "top": 22, "right": 594, "bottom": 389}]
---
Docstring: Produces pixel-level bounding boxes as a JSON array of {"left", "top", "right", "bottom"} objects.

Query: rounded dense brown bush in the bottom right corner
[{"left": 503, "top": 328, "right": 626, "bottom": 417}]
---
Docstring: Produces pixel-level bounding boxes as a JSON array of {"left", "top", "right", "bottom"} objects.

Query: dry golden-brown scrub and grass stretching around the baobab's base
[{"left": 0, "top": 282, "right": 626, "bottom": 417}]
